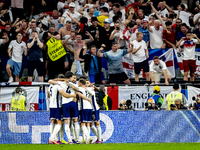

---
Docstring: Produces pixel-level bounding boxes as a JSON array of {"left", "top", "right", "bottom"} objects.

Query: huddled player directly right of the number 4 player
[{"left": 78, "top": 79, "right": 92, "bottom": 144}]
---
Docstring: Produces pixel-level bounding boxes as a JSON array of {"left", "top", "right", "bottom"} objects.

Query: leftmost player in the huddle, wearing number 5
[{"left": 47, "top": 75, "right": 65, "bottom": 144}]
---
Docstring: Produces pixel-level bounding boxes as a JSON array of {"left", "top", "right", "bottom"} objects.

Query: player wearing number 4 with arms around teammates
[{"left": 49, "top": 71, "right": 91, "bottom": 144}]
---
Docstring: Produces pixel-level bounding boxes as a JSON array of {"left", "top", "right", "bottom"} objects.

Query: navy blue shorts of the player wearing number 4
[{"left": 63, "top": 101, "right": 79, "bottom": 119}]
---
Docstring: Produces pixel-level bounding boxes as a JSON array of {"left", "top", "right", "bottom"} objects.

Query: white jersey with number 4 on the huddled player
[{"left": 60, "top": 82, "right": 77, "bottom": 104}]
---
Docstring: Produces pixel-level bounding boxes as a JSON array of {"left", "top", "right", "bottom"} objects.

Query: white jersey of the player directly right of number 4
[{"left": 78, "top": 87, "right": 92, "bottom": 110}]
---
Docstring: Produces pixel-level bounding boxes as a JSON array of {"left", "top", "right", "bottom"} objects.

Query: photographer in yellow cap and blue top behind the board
[{"left": 145, "top": 85, "right": 164, "bottom": 110}]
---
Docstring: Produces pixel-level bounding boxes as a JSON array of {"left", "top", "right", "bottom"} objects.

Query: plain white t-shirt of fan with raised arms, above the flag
[{"left": 149, "top": 26, "right": 163, "bottom": 49}]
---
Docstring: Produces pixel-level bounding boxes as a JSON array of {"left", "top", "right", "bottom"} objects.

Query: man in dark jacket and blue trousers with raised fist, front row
[{"left": 79, "top": 45, "right": 106, "bottom": 84}]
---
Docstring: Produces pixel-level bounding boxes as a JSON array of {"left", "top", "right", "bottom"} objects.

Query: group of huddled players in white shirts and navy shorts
[{"left": 47, "top": 71, "right": 103, "bottom": 144}]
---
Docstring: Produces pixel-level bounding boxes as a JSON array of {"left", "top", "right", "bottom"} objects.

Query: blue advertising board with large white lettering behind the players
[{"left": 0, "top": 110, "right": 200, "bottom": 144}]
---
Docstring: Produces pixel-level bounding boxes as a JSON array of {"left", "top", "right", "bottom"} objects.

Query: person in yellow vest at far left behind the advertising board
[{"left": 11, "top": 87, "right": 29, "bottom": 111}]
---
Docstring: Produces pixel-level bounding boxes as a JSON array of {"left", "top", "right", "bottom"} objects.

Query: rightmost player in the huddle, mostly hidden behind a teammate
[{"left": 86, "top": 80, "right": 103, "bottom": 144}]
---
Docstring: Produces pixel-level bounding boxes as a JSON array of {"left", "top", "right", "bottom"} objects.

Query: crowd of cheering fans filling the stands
[{"left": 0, "top": 0, "right": 200, "bottom": 85}]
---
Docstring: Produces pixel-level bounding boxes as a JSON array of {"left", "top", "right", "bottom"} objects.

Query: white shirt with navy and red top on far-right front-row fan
[{"left": 180, "top": 39, "right": 198, "bottom": 60}]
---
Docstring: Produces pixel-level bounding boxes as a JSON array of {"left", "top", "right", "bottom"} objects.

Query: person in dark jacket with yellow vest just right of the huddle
[{"left": 97, "top": 85, "right": 112, "bottom": 110}]
